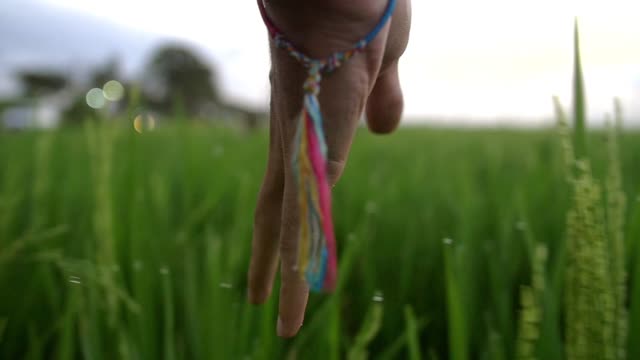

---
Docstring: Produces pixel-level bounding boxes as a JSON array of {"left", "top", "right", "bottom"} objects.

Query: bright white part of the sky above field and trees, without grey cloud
[{"left": 0, "top": 0, "right": 640, "bottom": 126}]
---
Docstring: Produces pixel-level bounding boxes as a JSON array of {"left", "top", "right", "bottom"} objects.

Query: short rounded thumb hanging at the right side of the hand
[{"left": 366, "top": 60, "right": 404, "bottom": 134}]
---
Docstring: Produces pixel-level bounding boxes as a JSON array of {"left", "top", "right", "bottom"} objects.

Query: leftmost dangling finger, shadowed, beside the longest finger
[{"left": 248, "top": 93, "right": 284, "bottom": 304}]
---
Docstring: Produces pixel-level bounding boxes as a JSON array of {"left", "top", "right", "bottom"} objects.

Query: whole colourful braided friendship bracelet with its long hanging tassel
[{"left": 258, "top": 0, "right": 396, "bottom": 291}]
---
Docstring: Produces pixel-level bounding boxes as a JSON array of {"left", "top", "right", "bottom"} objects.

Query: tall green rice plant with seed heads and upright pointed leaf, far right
[{"left": 556, "top": 22, "right": 627, "bottom": 360}]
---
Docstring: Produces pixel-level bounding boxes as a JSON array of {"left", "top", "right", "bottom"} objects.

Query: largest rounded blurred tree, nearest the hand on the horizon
[{"left": 143, "top": 44, "right": 220, "bottom": 116}]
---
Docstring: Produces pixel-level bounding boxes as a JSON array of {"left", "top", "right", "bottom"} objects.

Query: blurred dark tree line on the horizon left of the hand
[{"left": 0, "top": 43, "right": 262, "bottom": 128}]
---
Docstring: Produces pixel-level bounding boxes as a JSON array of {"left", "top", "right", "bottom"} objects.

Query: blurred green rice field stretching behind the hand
[{"left": 0, "top": 117, "right": 640, "bottom": 359}]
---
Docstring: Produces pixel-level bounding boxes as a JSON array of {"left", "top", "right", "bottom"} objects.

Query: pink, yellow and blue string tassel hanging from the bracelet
[{"left": 293, "top": 61, "right": 337, "bottom": 291}]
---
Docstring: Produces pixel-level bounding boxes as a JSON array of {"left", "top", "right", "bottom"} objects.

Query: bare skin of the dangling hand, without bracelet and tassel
[{"left": 248, "top": 0, "right": 411, "bottom": 337}]
